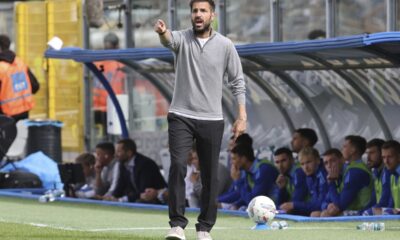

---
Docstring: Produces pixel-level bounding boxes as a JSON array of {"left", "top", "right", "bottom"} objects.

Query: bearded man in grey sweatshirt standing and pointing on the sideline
[{"left": 154, "top": 0, "right": 247, "bottom": 240}]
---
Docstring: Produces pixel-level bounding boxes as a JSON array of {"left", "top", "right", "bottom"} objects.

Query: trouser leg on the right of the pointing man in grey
[{"left": 195, "top": 120, "right": 224, "bottom": 232}]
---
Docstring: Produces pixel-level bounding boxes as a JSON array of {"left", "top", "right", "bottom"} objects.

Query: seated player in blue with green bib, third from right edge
[{"left": 321, "top": 135, "right": 376, "bottom": 217}]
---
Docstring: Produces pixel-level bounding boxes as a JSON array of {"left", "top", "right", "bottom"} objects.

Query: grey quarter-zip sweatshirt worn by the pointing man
[{"left": 162, "top": 29, "right": 246, "bottom": 120}]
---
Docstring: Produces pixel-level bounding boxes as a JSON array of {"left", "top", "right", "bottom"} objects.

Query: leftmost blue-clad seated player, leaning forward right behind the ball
[{"left": 218, "top": 144, "right": 278, "bottom": 209}]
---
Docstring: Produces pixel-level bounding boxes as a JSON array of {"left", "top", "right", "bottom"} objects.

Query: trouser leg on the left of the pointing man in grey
[{"left": 168, "top": 113, "right": 193, "bottom": 229}]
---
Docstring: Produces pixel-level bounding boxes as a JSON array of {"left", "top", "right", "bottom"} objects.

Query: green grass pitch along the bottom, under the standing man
[{"left": 0, "top": 197, "right": 400, "bottom": 240}]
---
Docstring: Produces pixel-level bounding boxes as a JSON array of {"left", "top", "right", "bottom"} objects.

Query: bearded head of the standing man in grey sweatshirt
[{"left": 192, "top": 2, "right": 215, "bottom": 34}]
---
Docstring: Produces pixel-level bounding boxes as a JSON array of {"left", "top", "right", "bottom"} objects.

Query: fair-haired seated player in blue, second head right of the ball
[{"left": 280, "top": 147, "right": 328, "bottom": 215}]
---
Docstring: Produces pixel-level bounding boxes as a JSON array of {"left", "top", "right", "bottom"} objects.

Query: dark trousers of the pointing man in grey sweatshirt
[{"left": 168, "top": 113, "right": 224, "bottom": 232}]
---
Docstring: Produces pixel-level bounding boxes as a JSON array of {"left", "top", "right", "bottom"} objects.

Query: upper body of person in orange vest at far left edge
[{"left": 0, "top": 35, "right": 39, "bottom": 122}]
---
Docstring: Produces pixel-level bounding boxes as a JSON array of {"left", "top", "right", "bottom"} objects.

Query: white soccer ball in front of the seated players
[{"left": 247, "top": 196, "right": 276, "bottom": 223}]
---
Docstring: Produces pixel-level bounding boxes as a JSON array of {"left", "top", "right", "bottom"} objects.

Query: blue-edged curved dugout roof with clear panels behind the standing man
[{"left": 45, "top": 32, "right": 400, "bottom": 149}]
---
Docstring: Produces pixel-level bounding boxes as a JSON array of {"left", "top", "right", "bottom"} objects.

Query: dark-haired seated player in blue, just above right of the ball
[{"left": 274, "top": 147, "right": 308, "bottom": 206}]
